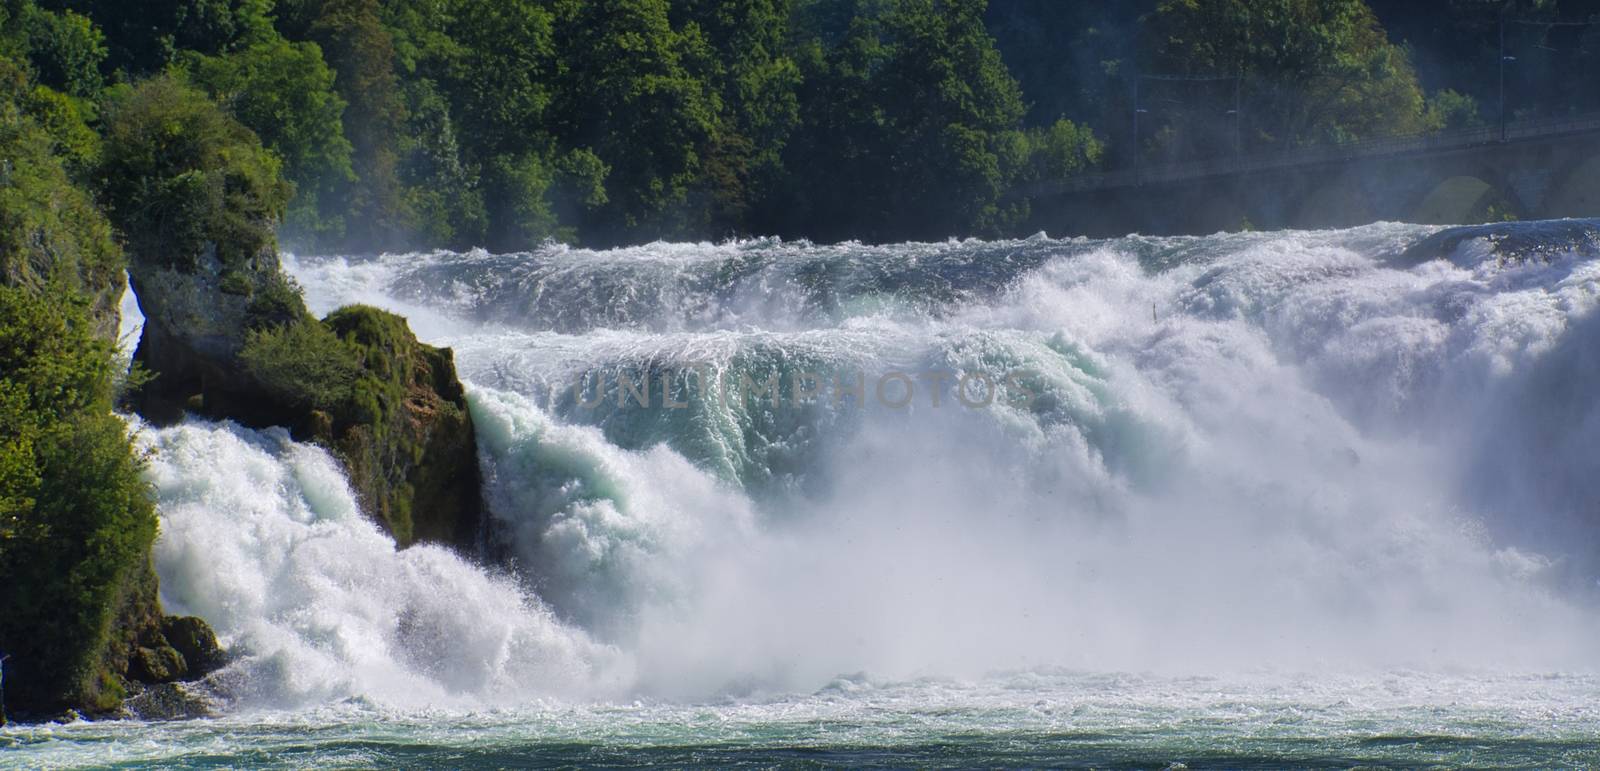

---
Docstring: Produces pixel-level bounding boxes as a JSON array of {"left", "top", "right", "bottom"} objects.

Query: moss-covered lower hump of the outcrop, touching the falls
[{"left": 148, "top": 297, "right": 483, "bottom": 552}]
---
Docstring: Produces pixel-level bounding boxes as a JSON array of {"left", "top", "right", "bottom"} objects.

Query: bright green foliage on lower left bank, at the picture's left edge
[{"left": 0, "top": 285, "right": 155, "bottom": 709}]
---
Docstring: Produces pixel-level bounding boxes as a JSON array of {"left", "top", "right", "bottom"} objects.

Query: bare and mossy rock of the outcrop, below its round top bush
[{"left": 130, "top": 251, "right": 483, "bottom": 552}]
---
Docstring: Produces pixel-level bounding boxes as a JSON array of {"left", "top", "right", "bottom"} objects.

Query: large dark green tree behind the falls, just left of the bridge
[{"left": 779, "top": 0, "right": 1024, "bottom": 240}]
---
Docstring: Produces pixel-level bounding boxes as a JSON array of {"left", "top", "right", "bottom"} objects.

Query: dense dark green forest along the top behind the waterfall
[{"left": 0, "top": 0, "right": 1600, "bottom": 251}]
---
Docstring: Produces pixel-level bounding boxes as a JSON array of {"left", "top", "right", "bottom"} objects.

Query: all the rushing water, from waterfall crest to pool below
[{"left": 0, "top": 224, "right": 1600, "bottom": 768}]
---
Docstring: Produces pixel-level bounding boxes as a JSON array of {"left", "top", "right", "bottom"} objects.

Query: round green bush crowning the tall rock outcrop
[{"left": 99, "top": 75, "right": 291, "bottom": 270}]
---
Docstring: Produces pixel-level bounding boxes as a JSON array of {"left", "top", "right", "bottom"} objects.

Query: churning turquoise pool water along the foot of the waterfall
[{"left": 9, "top": 672, "right": 1600, "bottom": 768}]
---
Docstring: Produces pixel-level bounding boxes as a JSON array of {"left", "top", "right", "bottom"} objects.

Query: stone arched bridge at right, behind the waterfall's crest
[{"left": 1021, "top": 115, "right": 1600, "bottom": 237}]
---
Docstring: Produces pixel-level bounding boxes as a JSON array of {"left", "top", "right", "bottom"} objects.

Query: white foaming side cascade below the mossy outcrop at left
[{"left": 139, "top": 419, "right": 627, "bottom": 707}]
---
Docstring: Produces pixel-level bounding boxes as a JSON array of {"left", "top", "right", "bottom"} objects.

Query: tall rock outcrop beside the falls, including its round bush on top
[{"left": 107, "top": 82, "right": 483, "bottom": 552}]
